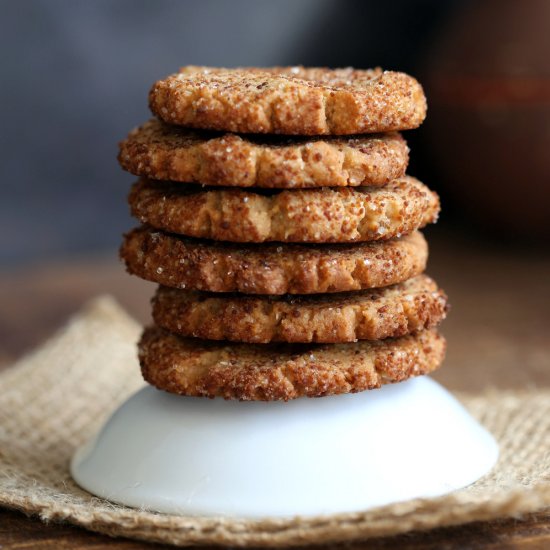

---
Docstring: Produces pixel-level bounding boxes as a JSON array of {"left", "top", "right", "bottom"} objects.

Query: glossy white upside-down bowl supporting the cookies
[{"left": 71, "top": 377, "right": 498, "bottom": 518}]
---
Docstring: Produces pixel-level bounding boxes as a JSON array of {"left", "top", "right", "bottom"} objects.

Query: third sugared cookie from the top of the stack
[{"left": 128, "top": 176, "right": 439, "bottom": 243}]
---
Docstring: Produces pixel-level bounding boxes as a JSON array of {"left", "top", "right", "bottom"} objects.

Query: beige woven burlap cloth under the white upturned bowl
[{"left": 0, "top": 298, "right": 550, "bottom": 546}]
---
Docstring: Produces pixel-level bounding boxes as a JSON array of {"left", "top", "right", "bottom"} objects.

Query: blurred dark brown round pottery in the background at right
[{"left": 425, "top": 0, "right": 550, "bottom": 237}]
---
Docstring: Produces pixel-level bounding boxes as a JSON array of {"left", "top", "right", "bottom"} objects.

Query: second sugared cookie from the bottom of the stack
[{"left": 153, "top": 275, "right": 447, "bottom": 343}]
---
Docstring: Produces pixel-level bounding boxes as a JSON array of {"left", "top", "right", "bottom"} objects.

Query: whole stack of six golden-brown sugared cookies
[{"left": 119, "top": 67, "right": 447, "bottom": 401}]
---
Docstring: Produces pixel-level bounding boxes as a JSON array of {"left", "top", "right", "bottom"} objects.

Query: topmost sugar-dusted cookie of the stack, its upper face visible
[{"left": 149, "top": 66, "right": 426, "bottom": 136}]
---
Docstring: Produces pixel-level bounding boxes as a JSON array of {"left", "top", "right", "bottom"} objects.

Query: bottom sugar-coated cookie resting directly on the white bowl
[{"left": 138, "top": 327, "right": 445, "bottom": 401}]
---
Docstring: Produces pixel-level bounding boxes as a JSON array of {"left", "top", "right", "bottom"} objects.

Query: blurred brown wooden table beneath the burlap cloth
[{"left": 0, "top": 230, "right": 550, "bottom": 550}]
